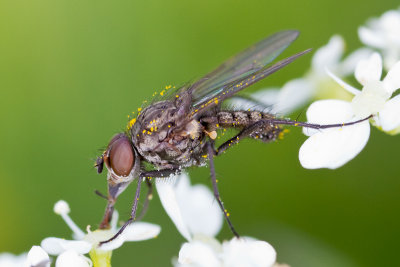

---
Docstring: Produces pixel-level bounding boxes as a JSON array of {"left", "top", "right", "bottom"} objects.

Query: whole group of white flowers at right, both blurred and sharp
[{"left": 233, "top": 6, "right": 400, "bottom": 169}]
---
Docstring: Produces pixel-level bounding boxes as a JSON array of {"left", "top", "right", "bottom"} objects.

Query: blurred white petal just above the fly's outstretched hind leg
[{"left": 273, "top": 79, "right": 317, "bottom": 114}]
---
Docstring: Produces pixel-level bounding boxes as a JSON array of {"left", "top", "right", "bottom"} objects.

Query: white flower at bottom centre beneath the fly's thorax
[{"left": 156, "top": 174, "right": 276, "bottom": 267}]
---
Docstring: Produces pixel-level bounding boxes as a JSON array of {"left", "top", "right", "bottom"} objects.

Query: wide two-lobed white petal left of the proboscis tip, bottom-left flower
[{"left": 41, "top": 237, "right": 92, "bottom": 255}]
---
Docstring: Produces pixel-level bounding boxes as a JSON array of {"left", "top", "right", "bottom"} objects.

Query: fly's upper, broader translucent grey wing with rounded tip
[{"left": 189, "top": 30, "right": 299, "bottom": 106}]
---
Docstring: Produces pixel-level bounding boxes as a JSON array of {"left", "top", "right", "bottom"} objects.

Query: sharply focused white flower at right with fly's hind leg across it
[{"left": 299, "top": 53, "right": 400, "bottom": 169}]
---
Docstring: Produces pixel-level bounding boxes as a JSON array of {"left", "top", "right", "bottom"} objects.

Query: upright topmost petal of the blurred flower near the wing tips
[{"left": 312, "top": 35, "right": 344, "bottom": 72}]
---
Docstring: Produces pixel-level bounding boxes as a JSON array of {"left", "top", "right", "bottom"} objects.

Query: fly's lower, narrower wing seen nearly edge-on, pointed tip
[{"left": 189, "top": 49, "right": 311, "bottom": 118}]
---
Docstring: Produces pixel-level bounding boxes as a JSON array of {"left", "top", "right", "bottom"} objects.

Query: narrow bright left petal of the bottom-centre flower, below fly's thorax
[{"left": 156, "top": 177, "right": 191, "bottom": 241}]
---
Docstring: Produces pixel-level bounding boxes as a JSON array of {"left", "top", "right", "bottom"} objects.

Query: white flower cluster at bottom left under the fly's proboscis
[{"left": 6, "top": 200, "right": 161, "bottom": 267}]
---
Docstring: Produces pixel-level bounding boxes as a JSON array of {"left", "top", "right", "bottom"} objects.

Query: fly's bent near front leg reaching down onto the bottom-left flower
[{"left": 100, "top": 168, "right": 180, "bottom": 246}]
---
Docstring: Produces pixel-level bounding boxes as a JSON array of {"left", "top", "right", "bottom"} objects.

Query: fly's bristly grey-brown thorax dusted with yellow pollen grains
[{"left": 130, "top": 100, "right": 204, "bottom": 169}]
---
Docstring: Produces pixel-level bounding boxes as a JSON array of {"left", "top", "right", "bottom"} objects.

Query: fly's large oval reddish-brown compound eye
[{"left": 108, "top": 134, "right": 135, "bottom": 176}]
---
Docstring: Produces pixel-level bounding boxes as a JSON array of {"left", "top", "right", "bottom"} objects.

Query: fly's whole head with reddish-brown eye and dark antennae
[{"left": 95, "top": 133, "right": 140, "bottom": 186}]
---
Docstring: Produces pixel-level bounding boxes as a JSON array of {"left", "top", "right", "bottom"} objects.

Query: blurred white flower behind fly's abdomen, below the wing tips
[{"left": 232, "top": 35, "right": 371, "bottom": 114}]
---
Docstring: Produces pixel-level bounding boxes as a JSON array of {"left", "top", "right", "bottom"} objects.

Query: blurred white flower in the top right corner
[{"left": 358, "top": 7, "right": 400, "bottom": 69}]
